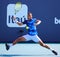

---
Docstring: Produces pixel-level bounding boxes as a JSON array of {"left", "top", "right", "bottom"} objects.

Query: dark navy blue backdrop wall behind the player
[{"left": 0, "top": 0, "right": 60, "bottom": 43}]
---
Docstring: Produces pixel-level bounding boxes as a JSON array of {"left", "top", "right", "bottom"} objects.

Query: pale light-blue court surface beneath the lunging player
[{"left": 0, "top": 43, "right": 60, "bottom": 57}]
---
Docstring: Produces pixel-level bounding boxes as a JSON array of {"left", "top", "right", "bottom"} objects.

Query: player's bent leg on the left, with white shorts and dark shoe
[{"left": 5, "top": 34, "right": 31, "bottom": 50}]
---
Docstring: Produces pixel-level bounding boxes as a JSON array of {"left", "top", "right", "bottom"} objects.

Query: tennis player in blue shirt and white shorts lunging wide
[{"left": 5, "top": 13, "right": 58, "bottom": 55}]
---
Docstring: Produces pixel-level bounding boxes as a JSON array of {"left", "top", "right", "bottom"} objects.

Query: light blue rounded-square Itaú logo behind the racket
[{"left": 7, "top": 4, "right": 28, "bottom": 27}]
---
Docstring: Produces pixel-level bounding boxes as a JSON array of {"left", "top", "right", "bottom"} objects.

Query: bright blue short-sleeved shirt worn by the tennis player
[{"left": 23, "top": 18, "right": 37, "bottom": 36}]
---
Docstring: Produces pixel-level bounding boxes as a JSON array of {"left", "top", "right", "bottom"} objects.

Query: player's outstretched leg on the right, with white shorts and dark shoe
[{"left": 31, "top": 35, "right": 57, "bottom": 55}]
